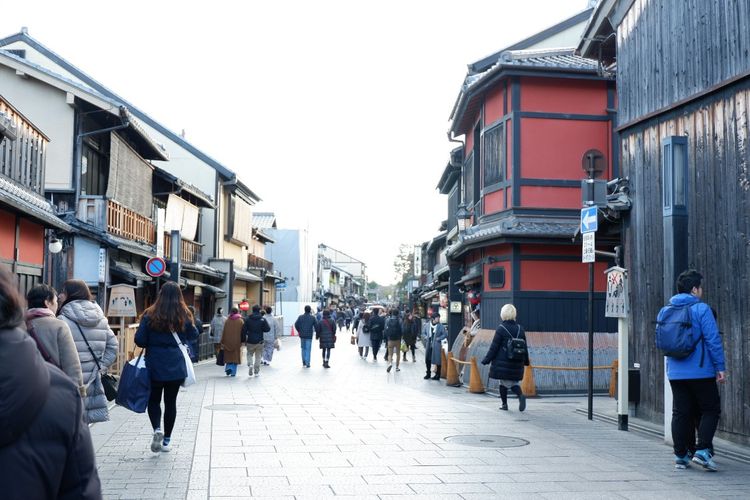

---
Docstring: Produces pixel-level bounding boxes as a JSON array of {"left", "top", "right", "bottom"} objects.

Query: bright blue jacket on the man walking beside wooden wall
[{"left": 667, "top": 293, "right": 726, "bottom": 380}]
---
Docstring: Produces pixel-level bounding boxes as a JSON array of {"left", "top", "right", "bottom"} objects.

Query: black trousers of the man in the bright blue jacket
[{"left": 669, "top": 378, "right": 721, "bottom": 457}]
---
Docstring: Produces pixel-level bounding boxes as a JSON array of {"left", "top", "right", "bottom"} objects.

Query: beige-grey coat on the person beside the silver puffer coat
[{"left": 26, "top": 307, "right": 86, "bottom": 397}]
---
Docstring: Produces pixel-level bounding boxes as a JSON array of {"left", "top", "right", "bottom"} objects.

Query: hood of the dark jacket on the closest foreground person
[{"left": 0, "top": 328, "right": 50, "bottom": 448}]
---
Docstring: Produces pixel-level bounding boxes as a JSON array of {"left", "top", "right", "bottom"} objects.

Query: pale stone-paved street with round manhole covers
[{"left": 92, "top": 334, "right": 750, "bottom": 500}]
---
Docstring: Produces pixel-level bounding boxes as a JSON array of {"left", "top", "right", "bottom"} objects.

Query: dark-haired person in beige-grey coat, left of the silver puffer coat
[{"left": 26, "top": 284, "right": 86, "bottom": 397}]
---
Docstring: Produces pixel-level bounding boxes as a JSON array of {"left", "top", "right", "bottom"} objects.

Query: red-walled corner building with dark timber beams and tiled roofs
[{"left": 435, "top": 10, "right": 618, "bottom": 342}]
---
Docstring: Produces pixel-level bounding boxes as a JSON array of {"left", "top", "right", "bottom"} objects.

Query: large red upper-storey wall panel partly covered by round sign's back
[{"left": 521, "top": 118, "right": 612, "bottom": 179}]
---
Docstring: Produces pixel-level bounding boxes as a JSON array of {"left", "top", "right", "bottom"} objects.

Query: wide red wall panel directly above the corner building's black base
[{"left": 521, "top": 260, "right": 607, "bottom": 292}]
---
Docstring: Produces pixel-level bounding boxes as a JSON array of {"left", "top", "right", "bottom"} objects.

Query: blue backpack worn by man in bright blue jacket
[{"left": 656, "top": 304, "right": 703, "bottom": 366}]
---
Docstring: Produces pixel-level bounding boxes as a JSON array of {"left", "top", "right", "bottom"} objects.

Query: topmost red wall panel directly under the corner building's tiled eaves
[{"left": 521, "top": 78, "right": 607, "bottom": 115}]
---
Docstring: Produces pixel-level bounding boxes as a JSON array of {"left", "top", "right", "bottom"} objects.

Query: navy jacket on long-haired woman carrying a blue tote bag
[{"left": 135, "top": 316, "right": 198, "bottom": 382}]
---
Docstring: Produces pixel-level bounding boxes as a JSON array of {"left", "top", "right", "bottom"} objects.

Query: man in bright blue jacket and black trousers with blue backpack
[{"left": 656, "top": 269, "right": 726, "bottom": 471}]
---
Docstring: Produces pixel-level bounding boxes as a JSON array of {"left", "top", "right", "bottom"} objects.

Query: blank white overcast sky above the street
[{"left": 0, "top": 0, "right": 588, "bottom": 284}]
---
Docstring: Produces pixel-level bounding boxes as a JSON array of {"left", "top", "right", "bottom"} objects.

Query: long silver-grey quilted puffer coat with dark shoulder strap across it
[{"left": 58, "top": 300, "right": 117, "bottom": 423}]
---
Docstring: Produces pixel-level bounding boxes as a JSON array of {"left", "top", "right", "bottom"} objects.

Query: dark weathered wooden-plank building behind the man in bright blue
[{"left": 579, "top": 0, "right": 750, "bottom": 443}]
